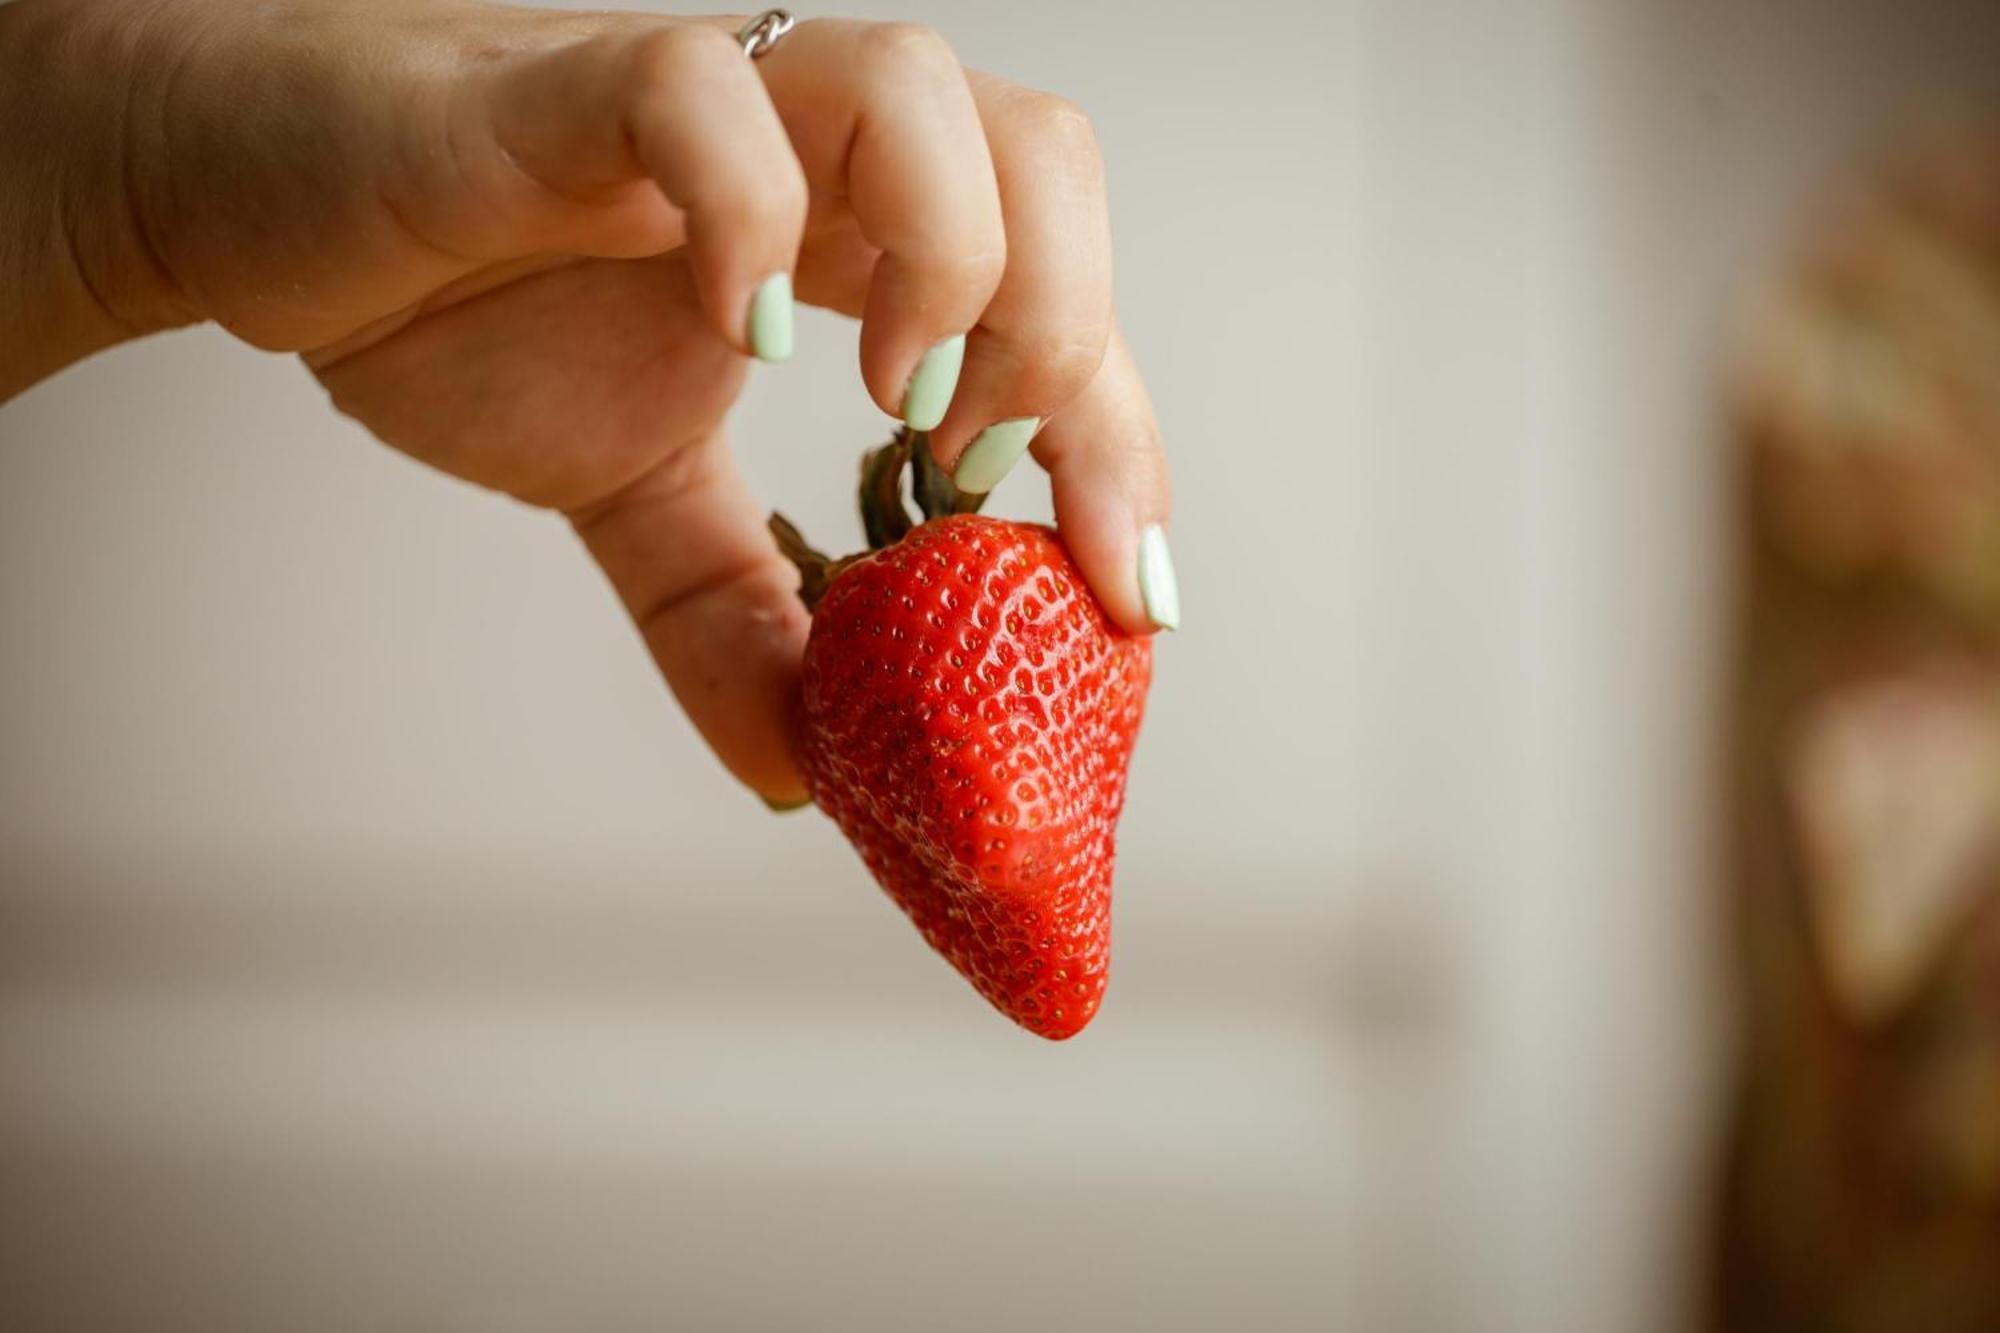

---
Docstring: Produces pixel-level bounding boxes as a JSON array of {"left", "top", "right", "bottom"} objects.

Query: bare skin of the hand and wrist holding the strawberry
[{"left": 0, "top": 0, "right": 1168, "bottom": 803}]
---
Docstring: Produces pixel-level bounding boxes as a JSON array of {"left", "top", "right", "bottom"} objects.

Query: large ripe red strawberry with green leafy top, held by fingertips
[{"left": 772, "top": 432, "right": 1152, "bottom": 1041}]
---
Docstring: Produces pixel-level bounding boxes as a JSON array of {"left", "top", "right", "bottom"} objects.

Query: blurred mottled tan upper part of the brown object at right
[{"left": 1744, "top": 119, "right": 2000, "bottom": 608}]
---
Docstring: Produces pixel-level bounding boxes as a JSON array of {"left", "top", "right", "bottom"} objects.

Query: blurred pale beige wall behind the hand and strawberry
[{"left": 0, "top": 0, "right": 2000, "bottom": 1333}]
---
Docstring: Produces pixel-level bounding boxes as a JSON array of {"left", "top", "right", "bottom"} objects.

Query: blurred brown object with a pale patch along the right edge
[{"left": 1720, "top": 124, "right": 2000, "bottom": 1333}]
